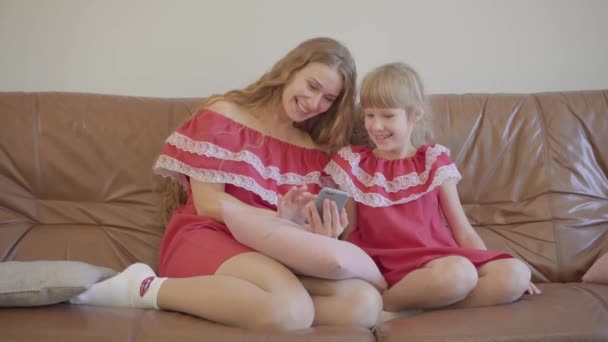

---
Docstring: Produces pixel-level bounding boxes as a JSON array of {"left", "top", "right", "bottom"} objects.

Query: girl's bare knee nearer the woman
[{"left": 434, "top": 256, "right": 479, "bottom": 304}]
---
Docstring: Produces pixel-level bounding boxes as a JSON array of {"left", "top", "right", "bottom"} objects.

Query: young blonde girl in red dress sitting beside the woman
[{"left": 326, "top": 63, "right": 540, "bottom": 311}]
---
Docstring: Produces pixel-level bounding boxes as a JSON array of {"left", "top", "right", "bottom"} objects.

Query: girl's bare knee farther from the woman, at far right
[{"left": 485, "top": 259, "right": 531, "bottom": 303}]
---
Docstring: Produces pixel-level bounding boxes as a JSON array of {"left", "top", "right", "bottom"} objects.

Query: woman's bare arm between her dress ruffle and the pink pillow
[{"left": 190, "top": 178, "right": 277, "bottom": 223}]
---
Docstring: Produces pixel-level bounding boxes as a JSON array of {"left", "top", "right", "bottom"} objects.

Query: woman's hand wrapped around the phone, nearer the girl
[{"left": 306, "top": 199, "right": 348, "bottom": 238}]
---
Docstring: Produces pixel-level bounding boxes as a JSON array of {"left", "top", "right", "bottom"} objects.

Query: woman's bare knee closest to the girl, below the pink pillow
[{"left": 343, "top": 279, "right": 382, "bottom": 328}]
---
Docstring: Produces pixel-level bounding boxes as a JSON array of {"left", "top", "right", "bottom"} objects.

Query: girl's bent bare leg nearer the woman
[{"left": 382, "top": 256, "right": 478, "bottom": 311}]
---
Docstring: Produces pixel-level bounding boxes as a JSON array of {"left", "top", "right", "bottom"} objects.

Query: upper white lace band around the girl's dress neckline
[{"left": 338, "top": 145, "right": 450, "bottom": 193}]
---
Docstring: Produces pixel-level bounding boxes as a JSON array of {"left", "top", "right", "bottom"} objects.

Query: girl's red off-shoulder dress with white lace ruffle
[{"left": 325, "top": 145, "right": 511, "bottom": 287}]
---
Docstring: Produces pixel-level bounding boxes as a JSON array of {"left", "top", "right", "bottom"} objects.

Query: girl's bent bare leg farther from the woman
[{"left": 454, "top": 259, "right": 531, "bottom": 307}]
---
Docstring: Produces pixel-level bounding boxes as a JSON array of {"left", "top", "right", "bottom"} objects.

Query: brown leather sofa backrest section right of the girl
[{"left": 432, "top": 91, "right": 608, "bottom": 282}]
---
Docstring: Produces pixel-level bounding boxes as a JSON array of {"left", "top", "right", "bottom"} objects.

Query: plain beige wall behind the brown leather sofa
[{"left": 0, "top": 0, "right": 608, "bottom": 97}]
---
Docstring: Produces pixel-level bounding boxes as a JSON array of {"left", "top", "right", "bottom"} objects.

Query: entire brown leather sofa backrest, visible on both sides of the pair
[{"left": 0, "top": 91, "right": 608, "bottom": 282}]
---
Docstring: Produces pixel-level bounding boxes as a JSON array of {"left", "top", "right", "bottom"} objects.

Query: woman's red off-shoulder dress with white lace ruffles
[{"left": 154, "top": 110, "right": 329, "bottom": 277}]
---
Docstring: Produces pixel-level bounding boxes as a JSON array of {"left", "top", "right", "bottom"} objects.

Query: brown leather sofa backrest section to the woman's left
[{"left": 0, "top": 93, "right": 197, "bottom": 270}]
